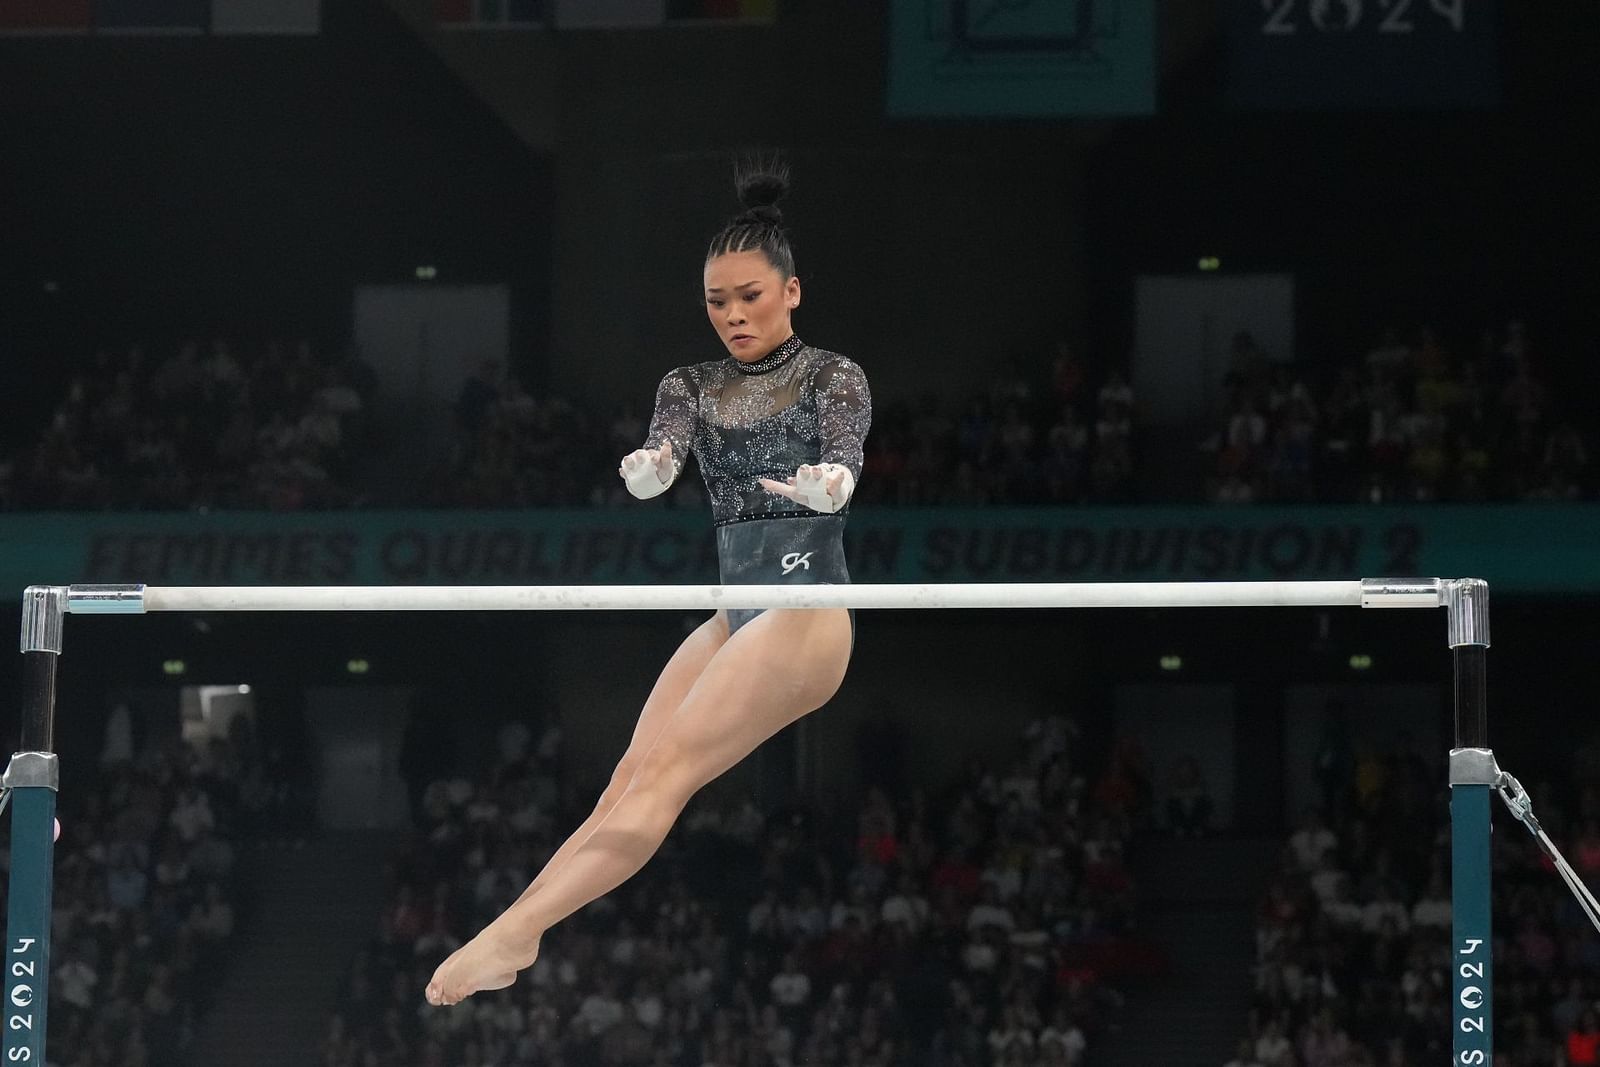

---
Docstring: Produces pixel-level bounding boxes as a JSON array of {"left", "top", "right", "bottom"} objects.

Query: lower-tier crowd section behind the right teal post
[{"left": 1227, "top": 723, "right": 1600, "bottom": 1067}]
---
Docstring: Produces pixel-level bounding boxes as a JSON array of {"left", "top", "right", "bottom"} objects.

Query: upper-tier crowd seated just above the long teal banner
[{"left": 0, "top": 322, "right": 1595, "bottom": 510}]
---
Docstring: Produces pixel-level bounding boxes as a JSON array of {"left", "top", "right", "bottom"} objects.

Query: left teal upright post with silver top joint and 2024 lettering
[{"left": 0, "top": 585, "right": 67, "bottom": 1067}]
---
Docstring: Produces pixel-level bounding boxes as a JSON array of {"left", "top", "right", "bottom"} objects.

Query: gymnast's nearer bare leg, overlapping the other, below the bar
[{"left": 427, "top": 608, "right": 851, "bottom": 1005}]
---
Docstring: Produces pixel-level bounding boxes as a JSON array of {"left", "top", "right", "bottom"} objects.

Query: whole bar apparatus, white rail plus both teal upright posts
[{"left": 3, "top": 577, "right": 1496, "bottom": 1064}]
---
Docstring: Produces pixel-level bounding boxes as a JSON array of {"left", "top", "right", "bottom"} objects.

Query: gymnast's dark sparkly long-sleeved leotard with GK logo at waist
[{"left": 645, "top": 336, "right": 872, "bottom": 633}]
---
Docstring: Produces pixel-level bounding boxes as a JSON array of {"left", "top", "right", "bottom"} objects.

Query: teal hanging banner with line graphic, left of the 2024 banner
[{"left": 888, "top": 0, "right": 1155, "bottom": 118}]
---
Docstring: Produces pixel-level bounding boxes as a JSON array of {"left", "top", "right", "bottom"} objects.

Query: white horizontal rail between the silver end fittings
[{"left": 124, "top": 581, "right": 1376, "bottom": 611}]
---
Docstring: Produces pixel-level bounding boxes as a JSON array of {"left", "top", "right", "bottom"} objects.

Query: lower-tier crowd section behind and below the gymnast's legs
[{"left": 322, "top": 718, "right": 1149, "bottom": 1067}]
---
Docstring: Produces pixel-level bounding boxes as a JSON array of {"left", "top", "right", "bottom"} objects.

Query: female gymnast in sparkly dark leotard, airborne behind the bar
[{"left": 427, "top": 168, "right": 872, "bottom": 1005}]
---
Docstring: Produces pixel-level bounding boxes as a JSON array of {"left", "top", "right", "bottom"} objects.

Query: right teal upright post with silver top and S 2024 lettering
[{"left": 1445, "top": 577, "right": 1499, "bottom": 1067}]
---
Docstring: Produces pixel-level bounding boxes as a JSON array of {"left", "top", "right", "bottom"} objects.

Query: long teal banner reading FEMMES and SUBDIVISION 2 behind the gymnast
[{"left": 0, "top": 504, "right": 1600, "bottom": 595}]
